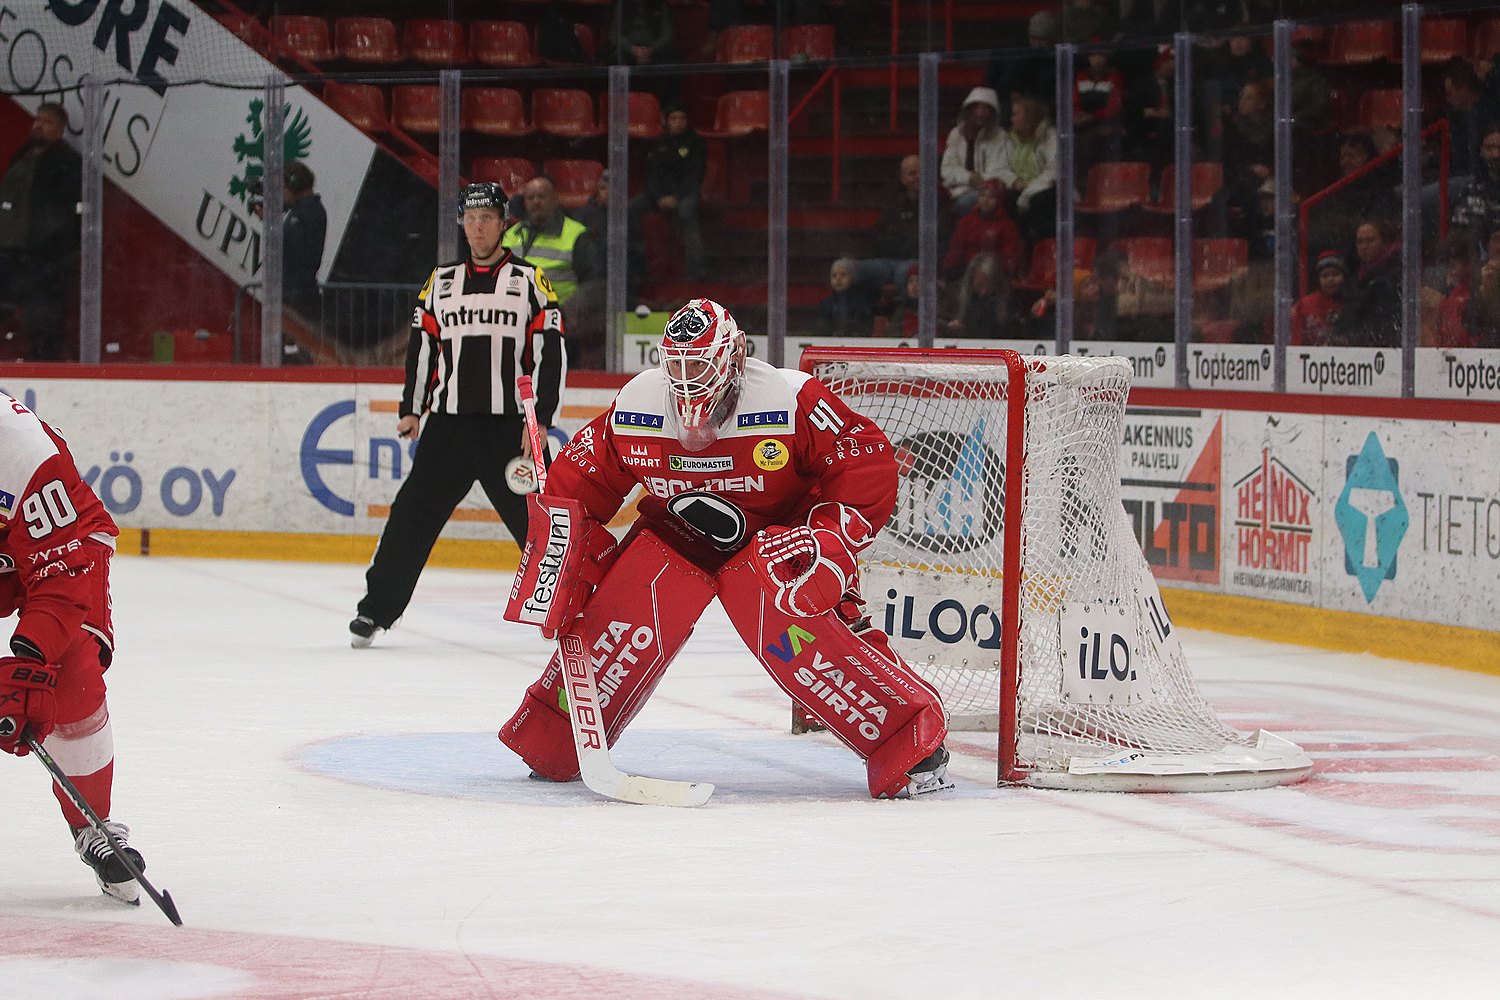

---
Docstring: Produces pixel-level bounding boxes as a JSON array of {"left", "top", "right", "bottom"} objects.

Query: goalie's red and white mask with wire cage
[{"left": 662, "top": 298, "right": 746, "bottom": 450}]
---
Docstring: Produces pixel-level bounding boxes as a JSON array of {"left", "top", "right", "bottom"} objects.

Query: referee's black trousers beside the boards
[{"left": 359, "top": 414, "right": 527, "bottom": 628}]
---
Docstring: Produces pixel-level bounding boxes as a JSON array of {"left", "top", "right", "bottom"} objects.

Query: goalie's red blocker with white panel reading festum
[{"left": 506, "top": 493, "right": 620, "bottom": 639}]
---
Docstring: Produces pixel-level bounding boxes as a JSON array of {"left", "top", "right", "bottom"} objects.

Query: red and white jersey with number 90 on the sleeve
[{"left": 0, "top": 393, "right": 120, "bottom": 663}]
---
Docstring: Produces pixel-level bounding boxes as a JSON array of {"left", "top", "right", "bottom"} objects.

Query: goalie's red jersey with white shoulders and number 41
[{"left": 548, "top": 358, "right": 897, "bottom": 562}]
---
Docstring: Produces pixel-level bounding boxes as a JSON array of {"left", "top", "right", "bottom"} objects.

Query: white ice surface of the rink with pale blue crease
[{"left": 0, "top": 558, "right": 1500, "bottom": 1000}]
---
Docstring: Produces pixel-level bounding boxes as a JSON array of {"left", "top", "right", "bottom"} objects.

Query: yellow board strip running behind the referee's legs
[{"left": 116, "top": 528, "right": 521, "bottom": 571}]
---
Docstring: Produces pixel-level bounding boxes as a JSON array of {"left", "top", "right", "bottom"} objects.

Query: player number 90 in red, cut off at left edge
[{"left": 0, "top": 393, "right": 146, "bottom": 904}]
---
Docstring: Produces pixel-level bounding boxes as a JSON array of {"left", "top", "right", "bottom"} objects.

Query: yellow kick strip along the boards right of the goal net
[{"left": 1163, "top": 588, "right": 1500, "bottom": 675}]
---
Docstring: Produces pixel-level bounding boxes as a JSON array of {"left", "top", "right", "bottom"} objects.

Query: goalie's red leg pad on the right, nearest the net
[{"left": 716, "top": 550, "right": 948, "bottom": 798}]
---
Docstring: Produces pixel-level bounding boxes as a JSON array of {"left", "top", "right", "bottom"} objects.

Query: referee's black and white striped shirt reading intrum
[{"left": 401, "top": 253, "right": 567, "bottom": 426}]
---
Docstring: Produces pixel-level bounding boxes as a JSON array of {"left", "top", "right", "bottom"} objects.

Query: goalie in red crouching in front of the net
[{"left": 500, "top": 298, "right": 951, "bottom": 798}]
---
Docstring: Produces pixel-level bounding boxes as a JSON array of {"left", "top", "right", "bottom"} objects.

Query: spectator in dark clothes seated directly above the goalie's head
[{"left": 630, "top": 103, "right": 708, "bottom": 286}]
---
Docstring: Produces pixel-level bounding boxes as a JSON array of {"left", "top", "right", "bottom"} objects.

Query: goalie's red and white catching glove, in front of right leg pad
[{"left": 750, "top": 504, "right": 873, "bottom": 618}]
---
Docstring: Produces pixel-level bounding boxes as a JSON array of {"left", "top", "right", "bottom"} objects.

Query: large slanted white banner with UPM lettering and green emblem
[{"left": 0, "top": 0, "right": 375, "bottom": 285}]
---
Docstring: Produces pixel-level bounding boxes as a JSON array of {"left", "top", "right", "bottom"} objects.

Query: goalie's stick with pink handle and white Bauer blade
[{"left": 516, "top": 375, "right": 714, "bottom": 805}]
